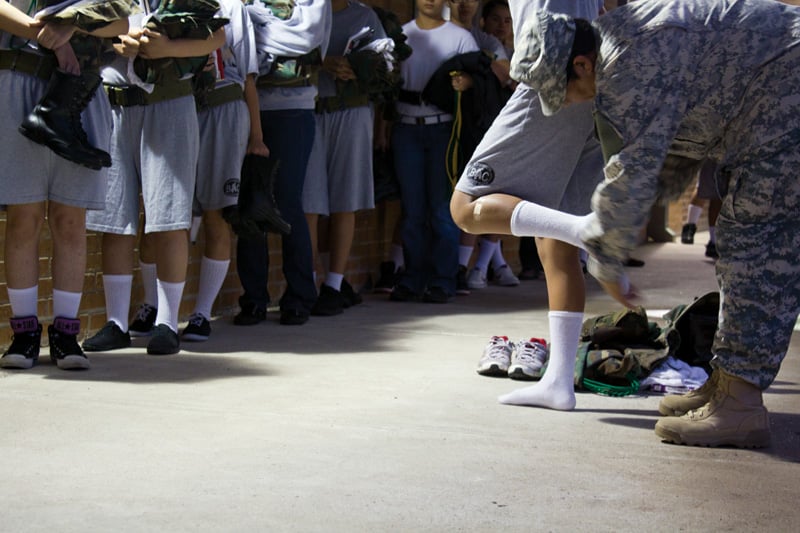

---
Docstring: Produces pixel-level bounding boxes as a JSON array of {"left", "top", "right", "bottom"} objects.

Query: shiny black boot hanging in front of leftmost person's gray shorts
[{"left": 19, "top": 70, "right": 111, "bottom": 170}]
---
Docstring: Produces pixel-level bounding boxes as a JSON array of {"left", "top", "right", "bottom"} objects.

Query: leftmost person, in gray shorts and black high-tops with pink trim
[{"left": 0, "top": 0, "right": 127, "bottom": 370}]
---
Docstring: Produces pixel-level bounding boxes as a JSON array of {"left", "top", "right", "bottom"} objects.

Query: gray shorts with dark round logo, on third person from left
[{"left": 193, "top": 100, "right": 250, "bottom": 215}]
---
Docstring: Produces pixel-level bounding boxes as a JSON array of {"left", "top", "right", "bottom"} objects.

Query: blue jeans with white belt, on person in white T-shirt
[{"left": 392, "top": 122, "right": 459, "bottom": 295}]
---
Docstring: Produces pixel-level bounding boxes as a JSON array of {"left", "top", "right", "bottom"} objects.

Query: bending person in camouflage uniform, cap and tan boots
[{"left": 506, "top": 0, "right": 800, "bottom": 447}]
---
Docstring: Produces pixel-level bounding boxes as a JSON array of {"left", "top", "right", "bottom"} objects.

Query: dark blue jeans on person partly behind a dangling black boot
[{"left": 236, "top": 109, "right": 317, "bottom": 314}]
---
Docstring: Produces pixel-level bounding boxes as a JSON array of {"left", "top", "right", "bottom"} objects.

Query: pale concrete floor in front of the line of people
[{"left": 0, "top": 238, "right": 800, "bottom": 532}]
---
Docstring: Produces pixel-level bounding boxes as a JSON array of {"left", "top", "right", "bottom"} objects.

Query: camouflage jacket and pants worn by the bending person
[{"left": 583, "top": 0, "right": 800, "bottom": 389}]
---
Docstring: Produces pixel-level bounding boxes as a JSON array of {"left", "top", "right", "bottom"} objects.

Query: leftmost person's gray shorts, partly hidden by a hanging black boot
[{"left": 0, "top": 70, "right": 111, "bottom": 209}]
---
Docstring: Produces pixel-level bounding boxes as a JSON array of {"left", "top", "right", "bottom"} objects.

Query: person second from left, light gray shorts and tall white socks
[{"left": 83, "top": 0, "right": 225, "bottom": 355}]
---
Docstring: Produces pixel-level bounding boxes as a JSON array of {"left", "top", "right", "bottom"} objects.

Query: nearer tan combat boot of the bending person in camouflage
[{"left": 656, "top": 370, "right": 770, "bottom": 448}]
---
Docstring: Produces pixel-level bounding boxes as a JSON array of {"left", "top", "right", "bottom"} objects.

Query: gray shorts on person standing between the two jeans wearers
[{"left": 303, "top": 106, "right": 375, "bottom": 215}]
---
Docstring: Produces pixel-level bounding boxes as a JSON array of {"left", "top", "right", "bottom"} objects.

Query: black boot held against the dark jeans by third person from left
[{"left": 239, "top": 154, "right": 292, "bottom": 235}]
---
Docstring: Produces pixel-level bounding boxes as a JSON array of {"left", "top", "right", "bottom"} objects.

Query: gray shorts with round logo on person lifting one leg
[{"left": 456, "top": 85, "right": 603, "bottom": 215}]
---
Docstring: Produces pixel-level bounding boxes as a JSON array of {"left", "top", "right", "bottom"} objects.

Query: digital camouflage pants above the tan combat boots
[{"left": 712, "top": 46, "right": 800, "bottom": 389}]
